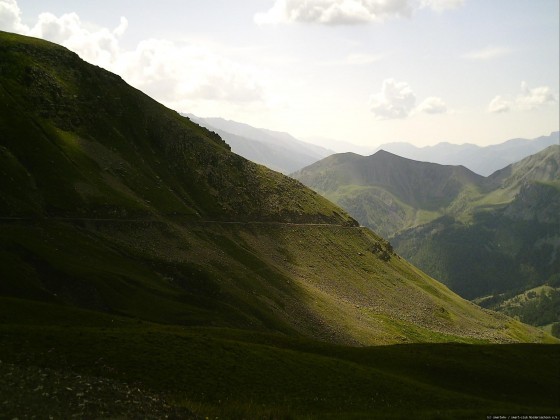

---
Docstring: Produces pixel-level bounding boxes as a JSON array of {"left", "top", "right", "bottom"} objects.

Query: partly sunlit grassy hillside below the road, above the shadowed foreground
[{"left": 0, "top": 220, "right": 547, "bottom": 344}]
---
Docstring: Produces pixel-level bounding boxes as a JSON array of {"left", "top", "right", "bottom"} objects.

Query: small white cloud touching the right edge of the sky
[{"left": 488, "top": 82, "right": 558, "bottom": 113}]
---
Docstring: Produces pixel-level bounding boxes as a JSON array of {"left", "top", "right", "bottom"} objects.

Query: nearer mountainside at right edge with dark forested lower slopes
[{"left": 393, "top": 146, "right": 560, "bottom": 298}]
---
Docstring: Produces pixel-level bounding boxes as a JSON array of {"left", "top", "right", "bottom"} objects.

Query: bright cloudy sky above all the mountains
[{"left": 0, "top": 0, "right": 560, "bottom": 148}]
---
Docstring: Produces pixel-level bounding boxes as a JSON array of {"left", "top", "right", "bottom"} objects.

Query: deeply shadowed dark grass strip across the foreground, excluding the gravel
[{"left": 0, "top": 299, "right": 560, "bottom": 418}]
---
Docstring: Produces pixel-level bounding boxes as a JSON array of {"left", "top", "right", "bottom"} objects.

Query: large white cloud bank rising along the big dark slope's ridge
[{"left": 0, "top": 0, "right": 265, "bottom": 106}]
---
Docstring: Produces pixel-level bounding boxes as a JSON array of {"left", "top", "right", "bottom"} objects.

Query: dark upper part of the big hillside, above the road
[{"left": 0, "top": 35, "right": 351, "bottom": 223}]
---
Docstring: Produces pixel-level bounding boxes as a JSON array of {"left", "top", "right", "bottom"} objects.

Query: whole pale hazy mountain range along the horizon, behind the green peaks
[{"left": 187, "top": 114, "right": 560, "bottom": 176}]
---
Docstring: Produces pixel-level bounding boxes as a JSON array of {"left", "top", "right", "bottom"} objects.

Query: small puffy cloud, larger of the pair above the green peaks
[{"left": 369, "top": 79, "right": 416, "bottom": 120}]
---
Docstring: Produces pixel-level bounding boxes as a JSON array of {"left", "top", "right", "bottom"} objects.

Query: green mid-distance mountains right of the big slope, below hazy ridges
[{"left": 294, "top": 145, "right": 560, "bottom": 306}]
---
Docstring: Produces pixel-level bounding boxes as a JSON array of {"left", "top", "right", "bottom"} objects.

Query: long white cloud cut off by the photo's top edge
[{"left": 254, "top": 0, "right": 464, "bottom": 25}]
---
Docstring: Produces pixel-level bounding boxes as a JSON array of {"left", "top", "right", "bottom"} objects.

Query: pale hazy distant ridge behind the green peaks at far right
[{"left": 376, "top": 131, "right": 560, "bottom": 176}]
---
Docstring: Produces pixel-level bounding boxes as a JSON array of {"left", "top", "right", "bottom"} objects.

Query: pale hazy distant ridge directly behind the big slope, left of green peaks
[{"left": 183, "top": 114, "right": 334, "bottom": 174}]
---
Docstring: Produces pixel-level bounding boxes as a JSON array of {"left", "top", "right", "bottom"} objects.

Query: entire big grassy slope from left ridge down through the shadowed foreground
[{"left": 0, "top": 33, "right": 558, "bottom": 418}]
